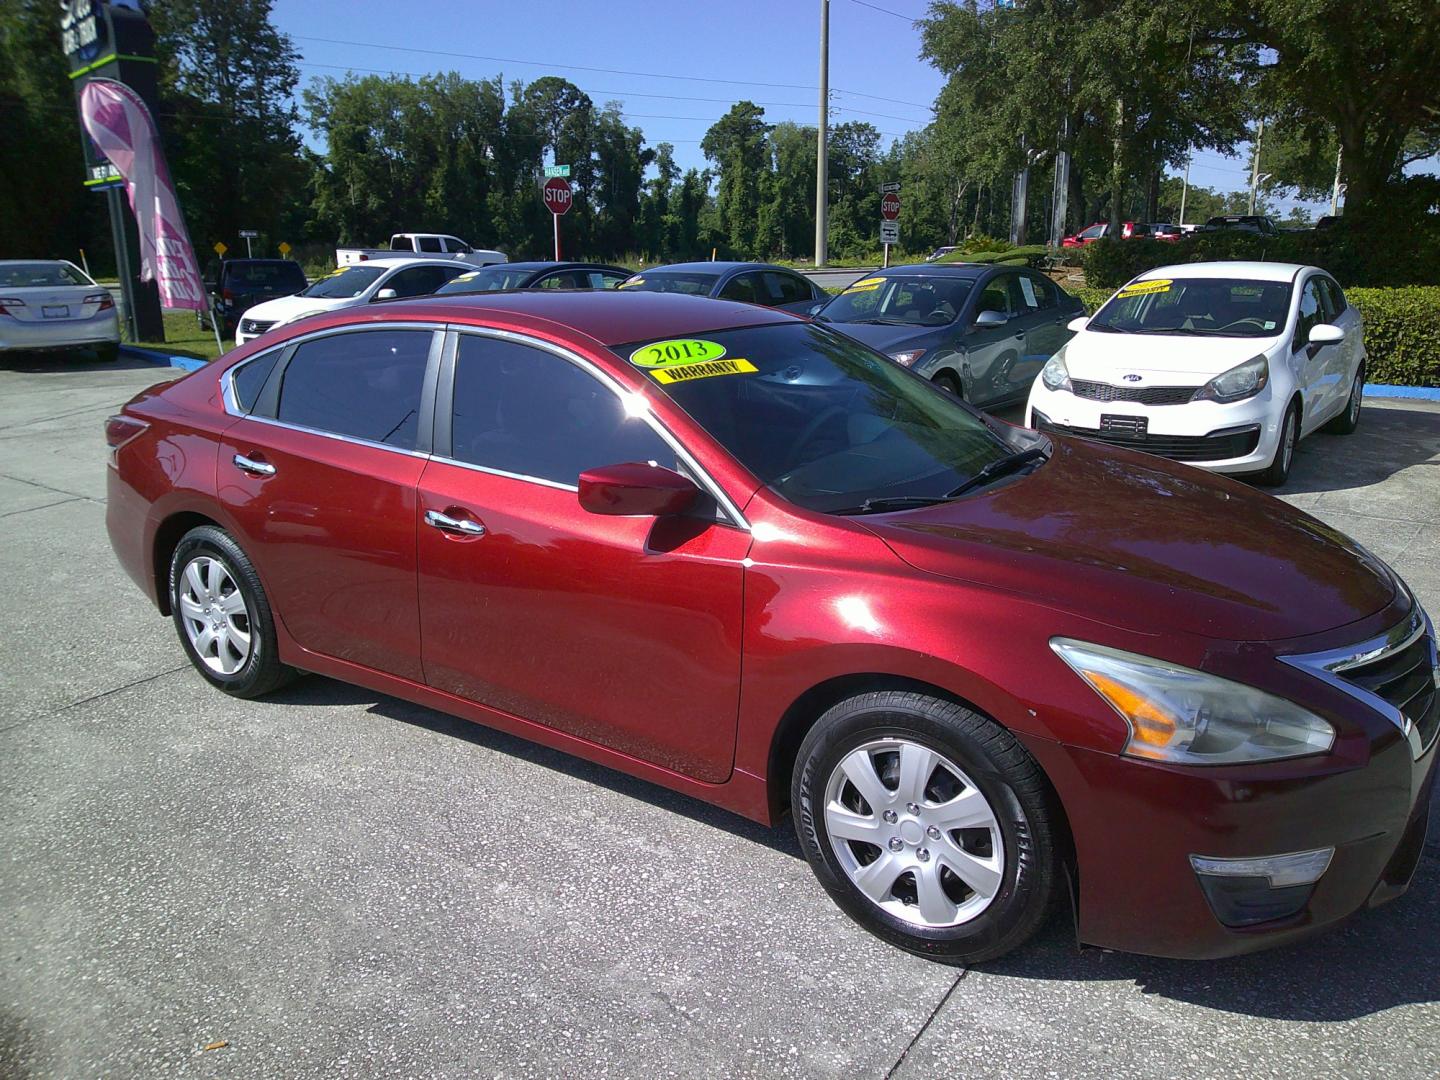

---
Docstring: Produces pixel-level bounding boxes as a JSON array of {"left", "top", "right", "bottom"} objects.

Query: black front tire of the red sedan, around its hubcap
[{"left": 791, "top": 690, "right": 1060, "bottom": 963}]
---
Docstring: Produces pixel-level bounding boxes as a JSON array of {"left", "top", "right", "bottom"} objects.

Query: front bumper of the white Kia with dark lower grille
[{"left": 1025, "top": 379, "right": 1284, "bottom": 474}]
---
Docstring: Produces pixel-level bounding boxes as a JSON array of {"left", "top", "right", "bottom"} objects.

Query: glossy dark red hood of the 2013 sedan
[{"left": 860, "top": 438, "right": 1395, "bottom": 641}]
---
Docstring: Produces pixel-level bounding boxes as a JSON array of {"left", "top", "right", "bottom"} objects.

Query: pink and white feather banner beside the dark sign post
[{"left": 81, "top": 79, "right": 207, "bottom": 311}]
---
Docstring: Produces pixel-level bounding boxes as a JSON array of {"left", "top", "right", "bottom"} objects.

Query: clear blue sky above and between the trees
[{"left": 267, "top": 0, "right": 1328, "bottom": 220}]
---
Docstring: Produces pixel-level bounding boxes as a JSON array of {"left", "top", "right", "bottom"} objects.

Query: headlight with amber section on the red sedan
[{"left": 1050, "top": 638, "right": 1335, "bottom": 765}]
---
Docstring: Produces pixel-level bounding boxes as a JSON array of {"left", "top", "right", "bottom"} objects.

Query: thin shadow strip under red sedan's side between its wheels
[{"left": 265, "top": 675, "right": 804, "bottom": 858}]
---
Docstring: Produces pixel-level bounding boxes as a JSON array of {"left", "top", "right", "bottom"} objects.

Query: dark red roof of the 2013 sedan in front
[{"left": 365, "top": 289, "right": 799, "bottom": 346}]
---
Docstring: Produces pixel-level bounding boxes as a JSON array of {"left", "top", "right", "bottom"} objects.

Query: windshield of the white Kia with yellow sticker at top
[{"left": 1086, "top": 278, "right": 1290, "bottom": 337}]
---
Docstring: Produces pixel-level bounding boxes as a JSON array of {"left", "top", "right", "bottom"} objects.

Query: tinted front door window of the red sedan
[{"left": 451, "top": 334, "right": 675, "bottom": 485}]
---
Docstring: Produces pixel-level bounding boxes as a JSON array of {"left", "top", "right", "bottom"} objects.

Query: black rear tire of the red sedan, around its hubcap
[{"left": 170, "top": 526, "right": 300, "bottom": 697}]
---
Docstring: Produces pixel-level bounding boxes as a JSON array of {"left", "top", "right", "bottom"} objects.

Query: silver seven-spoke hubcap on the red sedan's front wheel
[{"left": 825, "top": 739, "right": 1005, "bottom": 929}]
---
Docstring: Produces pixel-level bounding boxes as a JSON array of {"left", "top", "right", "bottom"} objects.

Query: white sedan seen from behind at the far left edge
[{"left": 0, "top": 259, "right": 120, "bottom": 360}]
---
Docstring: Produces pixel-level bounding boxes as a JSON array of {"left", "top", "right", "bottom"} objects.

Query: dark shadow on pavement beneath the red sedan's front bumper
[{"left": 978, "top": 848, "right": 1440, "bottom": 1021}]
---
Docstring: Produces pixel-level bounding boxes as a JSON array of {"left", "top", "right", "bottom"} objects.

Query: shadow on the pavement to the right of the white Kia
[{"left": 1270, "top": 403, "right": 1440, "bottom": 495}]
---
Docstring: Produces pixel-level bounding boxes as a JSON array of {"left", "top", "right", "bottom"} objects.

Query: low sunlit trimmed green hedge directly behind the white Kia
[{"left": 1070, "top": 285, "right": 1440, "bottom": 386}]
